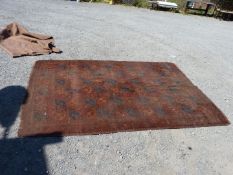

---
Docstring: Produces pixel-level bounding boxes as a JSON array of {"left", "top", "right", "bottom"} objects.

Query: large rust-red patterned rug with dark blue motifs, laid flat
[{"left": 18, "top": 61, "right": 229, "bottom": 136}]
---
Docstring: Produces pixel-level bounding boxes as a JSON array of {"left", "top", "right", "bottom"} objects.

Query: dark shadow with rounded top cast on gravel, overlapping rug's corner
[{"left": 0, "top": 86, "right": 62, "bottom": 175}]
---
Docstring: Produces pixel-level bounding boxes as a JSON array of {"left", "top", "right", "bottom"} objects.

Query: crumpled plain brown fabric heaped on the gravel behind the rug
[{"left": 0, "top": 23, "right": 61, "bottom": 57}]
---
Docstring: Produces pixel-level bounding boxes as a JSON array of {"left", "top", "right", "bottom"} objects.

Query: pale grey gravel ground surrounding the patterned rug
[{"left": 0, "top": 0, "right": 233, "bottom": 175}]
